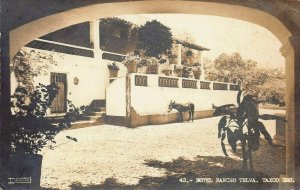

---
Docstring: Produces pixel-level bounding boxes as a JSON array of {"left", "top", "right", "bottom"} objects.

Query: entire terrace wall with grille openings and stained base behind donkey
[{"left": 106, "top": 74, "right": 239, "bottom": 127}]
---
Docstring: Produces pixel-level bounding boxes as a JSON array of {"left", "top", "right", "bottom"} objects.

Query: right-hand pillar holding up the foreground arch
[{"left": 280, "top": 36, "right": 300, "bottom": 189}]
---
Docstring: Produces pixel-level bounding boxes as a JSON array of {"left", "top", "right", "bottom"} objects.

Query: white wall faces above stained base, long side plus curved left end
[{"left": 106, "top": 74, "right": 238, "bottom": 116}]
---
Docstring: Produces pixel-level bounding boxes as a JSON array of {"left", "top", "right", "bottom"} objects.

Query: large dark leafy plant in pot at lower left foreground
[{"left": 5, "top": 84, "right": 76, "bottom": 189}]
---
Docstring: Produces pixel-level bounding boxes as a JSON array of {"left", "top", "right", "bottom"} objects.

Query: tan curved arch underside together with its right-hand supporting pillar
[{"left": 3, "top": 1, "right": 299, "bottom": 188}]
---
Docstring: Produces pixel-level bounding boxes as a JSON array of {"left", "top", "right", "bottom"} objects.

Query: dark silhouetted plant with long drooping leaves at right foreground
[{"left": 213, "top": 91, "right": 286, "bottom": 172}]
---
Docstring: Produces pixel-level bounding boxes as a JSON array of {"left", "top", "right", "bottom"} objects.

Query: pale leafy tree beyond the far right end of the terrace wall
[{"left": 206, "top": 53, "right": 285, "bottom": 105}]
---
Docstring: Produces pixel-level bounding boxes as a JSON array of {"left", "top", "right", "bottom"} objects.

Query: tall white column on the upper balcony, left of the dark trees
[{"left": 90, "top": 20, "right": 102, "bottom": 59}]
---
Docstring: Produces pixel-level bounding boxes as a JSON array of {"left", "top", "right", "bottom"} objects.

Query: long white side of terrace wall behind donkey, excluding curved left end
[{"left": 131, "top": 75, "right": 237, "bottom": 115}]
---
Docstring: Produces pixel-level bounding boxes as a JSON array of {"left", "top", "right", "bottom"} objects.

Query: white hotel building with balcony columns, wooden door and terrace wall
[{"left": 11, "top": 20, "right": 239, "bottom": 127}]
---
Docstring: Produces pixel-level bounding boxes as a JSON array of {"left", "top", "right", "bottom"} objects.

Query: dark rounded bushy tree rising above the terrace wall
[{"left": 137, "top": 20, "right": 173, "bottom": 58}]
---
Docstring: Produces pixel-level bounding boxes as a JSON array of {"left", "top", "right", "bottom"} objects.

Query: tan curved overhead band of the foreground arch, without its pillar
[{"left": 10, "top": 1, "right": 291, "bottom": 57}]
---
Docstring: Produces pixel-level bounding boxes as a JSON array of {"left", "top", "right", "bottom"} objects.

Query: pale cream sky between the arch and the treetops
[{"left": 119, "top": 14, "right": 285, "bottom": 69}]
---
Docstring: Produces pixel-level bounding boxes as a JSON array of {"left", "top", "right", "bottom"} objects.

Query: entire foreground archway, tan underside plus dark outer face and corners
[{"left": 1, "top": 0, "right": 300, "bottom": 189}]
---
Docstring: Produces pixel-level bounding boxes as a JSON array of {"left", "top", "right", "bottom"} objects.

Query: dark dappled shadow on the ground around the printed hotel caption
[{"left": 64, "top": 156, "right": 278, "bottom": 190}]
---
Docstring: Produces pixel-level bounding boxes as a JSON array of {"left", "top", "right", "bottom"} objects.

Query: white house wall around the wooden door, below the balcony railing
[{"left": 11, "top": 47, "right": 111, "bottom": 106}]
